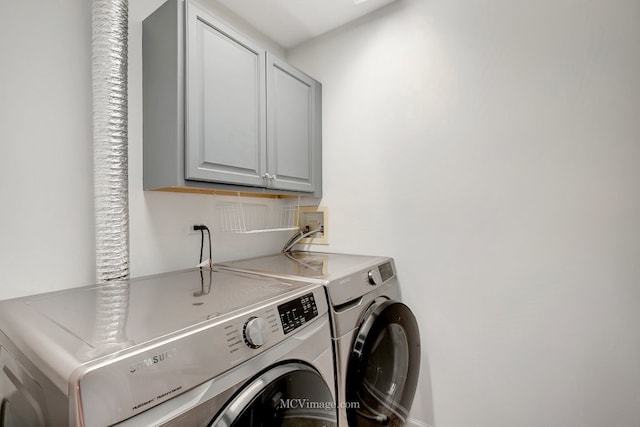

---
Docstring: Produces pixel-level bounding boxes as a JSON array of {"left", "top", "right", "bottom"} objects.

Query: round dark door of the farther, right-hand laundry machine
[{"left": 345, "top": 300, "right": 420, "bottom": 427}]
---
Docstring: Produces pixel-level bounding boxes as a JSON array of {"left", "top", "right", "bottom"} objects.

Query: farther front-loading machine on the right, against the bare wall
[{"left": 218, "top": 251, "right": 420, "bottom": 427}]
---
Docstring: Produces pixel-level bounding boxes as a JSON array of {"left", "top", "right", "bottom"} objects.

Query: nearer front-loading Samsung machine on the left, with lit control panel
[{"left": 0, "top": 269, "right": 337, "bottom": 427}]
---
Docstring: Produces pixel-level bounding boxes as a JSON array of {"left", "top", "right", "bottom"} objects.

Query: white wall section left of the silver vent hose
[{"left": 0, "top": 0, "right": 94, "bottom": 299}]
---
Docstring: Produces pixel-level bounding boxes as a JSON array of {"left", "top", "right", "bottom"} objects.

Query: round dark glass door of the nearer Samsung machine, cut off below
[{"left": 209, "top": 362, "right": 337, "bottom": 427}]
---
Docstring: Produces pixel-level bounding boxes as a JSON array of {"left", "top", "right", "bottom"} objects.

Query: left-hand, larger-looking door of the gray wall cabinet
[{"left": 185, "top": 2, "right": 266, "bottom": 186}]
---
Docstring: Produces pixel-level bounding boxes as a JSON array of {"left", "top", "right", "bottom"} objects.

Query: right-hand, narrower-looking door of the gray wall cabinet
[{"left": 267, "top": 53, "right": 322, "bottom": 192}]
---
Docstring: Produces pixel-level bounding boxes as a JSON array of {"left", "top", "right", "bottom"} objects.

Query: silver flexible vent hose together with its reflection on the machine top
[{"left": 92, "top": 0, "right": 129, "bottom": 353}]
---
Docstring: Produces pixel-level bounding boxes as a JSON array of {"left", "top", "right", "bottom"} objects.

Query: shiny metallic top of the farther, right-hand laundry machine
[{"left": 218, "top": 251, "right": 389, "bottom": 284}]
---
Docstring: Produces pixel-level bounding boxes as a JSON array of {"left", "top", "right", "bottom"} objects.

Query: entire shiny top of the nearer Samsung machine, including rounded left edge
[{"left": 0, "top": 269, "right": 311, "bottom": 384}]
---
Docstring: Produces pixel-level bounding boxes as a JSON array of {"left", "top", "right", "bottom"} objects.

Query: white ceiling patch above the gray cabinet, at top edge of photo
[{"left": 218, "top": 0, "right": 395, "bottom": 48}]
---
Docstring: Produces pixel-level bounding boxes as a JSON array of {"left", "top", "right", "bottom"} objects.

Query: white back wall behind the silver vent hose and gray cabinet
[{"left": 0, "top": 0, "right": 290, "bottom": 299}]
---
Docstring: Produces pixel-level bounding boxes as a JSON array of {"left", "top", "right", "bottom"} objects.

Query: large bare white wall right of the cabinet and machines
[{"left": 288, "top": 0, "right": 640, "bottom": 427}]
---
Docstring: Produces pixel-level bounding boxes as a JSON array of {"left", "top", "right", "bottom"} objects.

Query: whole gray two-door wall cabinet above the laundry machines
[{"left": 143, "top": 0, "right": 322, "bottom": 196}]
